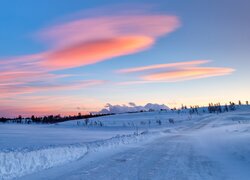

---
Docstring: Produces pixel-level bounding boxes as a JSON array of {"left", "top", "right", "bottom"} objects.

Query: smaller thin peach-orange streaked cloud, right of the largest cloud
[{"left": 117, "top": 60, "right": 235, "bottom": 85}]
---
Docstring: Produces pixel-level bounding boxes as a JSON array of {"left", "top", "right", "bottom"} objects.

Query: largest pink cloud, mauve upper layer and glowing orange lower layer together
[{"left": 34, "top": 15, "right": 180, "bottom": 69}]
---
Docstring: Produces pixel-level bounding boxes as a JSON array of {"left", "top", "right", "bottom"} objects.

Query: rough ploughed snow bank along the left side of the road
[{"left": 0, "top": 133, "right": 155, "bottom": 179}]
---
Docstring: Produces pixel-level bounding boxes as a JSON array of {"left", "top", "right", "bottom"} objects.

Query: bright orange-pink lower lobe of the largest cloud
[{"left": 41, "top": 36, "right": 154, "bottom": 69}]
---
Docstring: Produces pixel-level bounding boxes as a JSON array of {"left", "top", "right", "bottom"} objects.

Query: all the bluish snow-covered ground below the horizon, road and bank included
[{"left": 0, "top": 106, "right": 250, "bottom": 180}]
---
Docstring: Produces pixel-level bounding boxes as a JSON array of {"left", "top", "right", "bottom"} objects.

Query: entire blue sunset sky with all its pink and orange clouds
[{"left": 0, "top": 0, "right": 250, "bottom": 117}]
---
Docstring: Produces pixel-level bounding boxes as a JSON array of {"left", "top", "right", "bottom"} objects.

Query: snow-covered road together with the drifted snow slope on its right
[{"left": 19, "top": 114, "right": 250, "bottom": 180}]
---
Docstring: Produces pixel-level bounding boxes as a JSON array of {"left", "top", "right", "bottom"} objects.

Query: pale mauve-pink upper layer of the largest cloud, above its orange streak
[{"left": 38, "top": 14, "right": 180, "bottom": 47}]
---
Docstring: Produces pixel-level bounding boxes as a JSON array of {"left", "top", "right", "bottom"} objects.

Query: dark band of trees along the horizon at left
[{"left": 0, "top": 113, "right": 113, "bottom": 124}]
